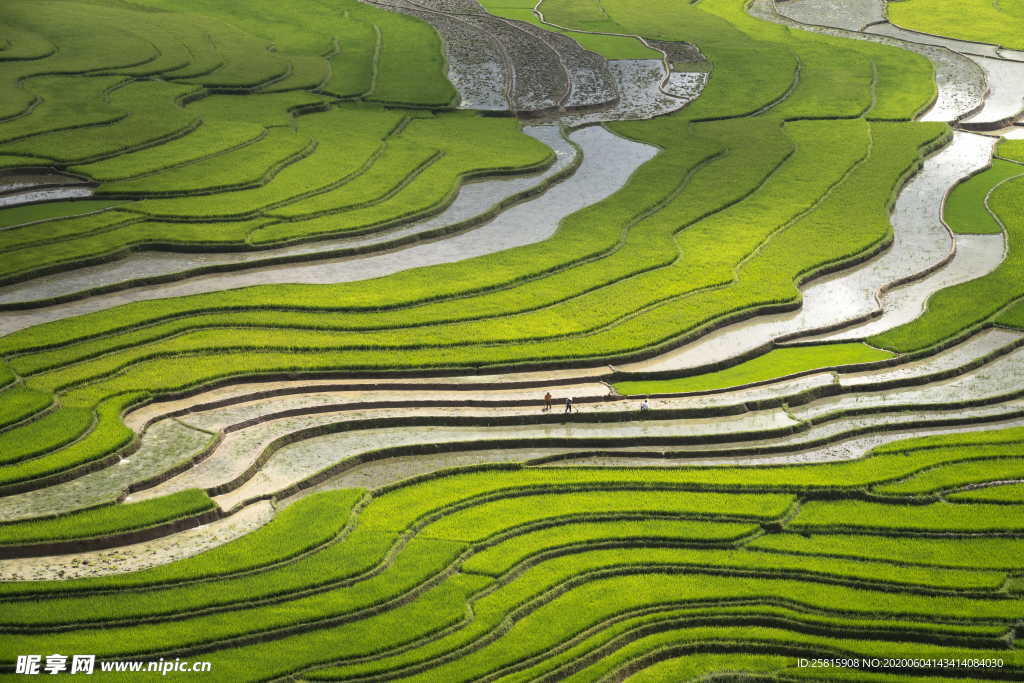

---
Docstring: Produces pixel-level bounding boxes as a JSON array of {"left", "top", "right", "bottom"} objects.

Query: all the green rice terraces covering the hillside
[{"left": 0, "top": 0, "right": 1024, "bottom": 681}]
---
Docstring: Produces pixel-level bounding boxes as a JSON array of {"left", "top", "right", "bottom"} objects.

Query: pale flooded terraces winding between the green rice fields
[{"left": 0, "top": 0, "right": 1024, "bottom": 580}]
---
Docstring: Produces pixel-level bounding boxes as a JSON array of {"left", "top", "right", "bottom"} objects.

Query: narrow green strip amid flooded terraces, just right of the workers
[{"left": 614, "top": 343, "right": 893, "bottom": 396}]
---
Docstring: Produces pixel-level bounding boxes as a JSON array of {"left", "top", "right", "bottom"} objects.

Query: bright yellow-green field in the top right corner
[{"left": 888, "top": 0, "right": 1024, "bottom": 49}]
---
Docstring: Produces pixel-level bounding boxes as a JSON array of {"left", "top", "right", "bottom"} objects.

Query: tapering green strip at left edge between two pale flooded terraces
[{"left": 0, "top": 488, "right": 216, "bottom": 545}]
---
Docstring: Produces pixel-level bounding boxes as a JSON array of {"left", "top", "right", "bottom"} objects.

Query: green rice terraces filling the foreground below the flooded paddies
[{"left": 0, "top": 444, "right": 1021, "bottom": 680}]
